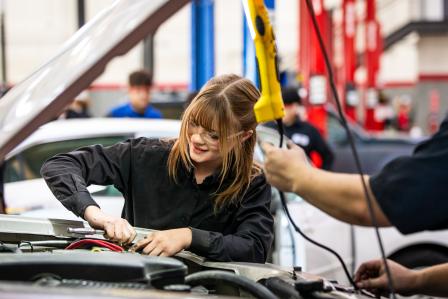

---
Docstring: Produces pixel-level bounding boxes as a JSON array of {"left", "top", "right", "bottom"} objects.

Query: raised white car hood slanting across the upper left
[{"left": 0, "top": 0, "right": 189, "bottom": 161}]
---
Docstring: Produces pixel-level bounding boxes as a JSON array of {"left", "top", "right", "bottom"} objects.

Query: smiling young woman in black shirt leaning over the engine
[{"left": 41, "top": 75, "right": 273, "bottom": 262}]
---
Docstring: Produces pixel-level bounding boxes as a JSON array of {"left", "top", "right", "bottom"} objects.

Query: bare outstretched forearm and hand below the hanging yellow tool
[{"left": 263, "top": 142, "right": 390, "bottom": 226}]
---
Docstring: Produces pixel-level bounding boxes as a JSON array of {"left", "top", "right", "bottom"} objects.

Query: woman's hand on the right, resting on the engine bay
[{"left": 130, "top": 227, "right": 192, "bottom": 256}]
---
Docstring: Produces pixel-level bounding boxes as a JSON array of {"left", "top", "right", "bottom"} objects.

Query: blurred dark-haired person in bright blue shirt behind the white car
[{"left": 107, "top": 70, "right": 162, "bottom": 118}]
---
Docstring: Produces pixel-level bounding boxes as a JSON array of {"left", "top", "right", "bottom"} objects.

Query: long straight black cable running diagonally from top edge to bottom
[{"left": 305, "top": 0, "right": 396, "bottom": 299}]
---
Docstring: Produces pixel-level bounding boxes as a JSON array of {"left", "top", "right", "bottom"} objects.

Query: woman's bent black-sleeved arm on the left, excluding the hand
[{"left": 41, "top": 141, "right": 131, "bottom": 217}]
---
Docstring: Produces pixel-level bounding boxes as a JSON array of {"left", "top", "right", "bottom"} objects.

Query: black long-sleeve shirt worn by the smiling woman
[{"left": 41, "top": 138, "right": 273, "bottom": 262}]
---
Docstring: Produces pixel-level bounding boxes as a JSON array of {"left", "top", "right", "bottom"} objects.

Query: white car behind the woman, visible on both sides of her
[{"left": 5, "top": 119, "right": 448, "bottom": 281}]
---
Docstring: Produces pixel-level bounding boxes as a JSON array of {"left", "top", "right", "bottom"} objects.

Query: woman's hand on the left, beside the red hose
[{"left": 84, "top": 206, "right": 137, "bottom": 244}]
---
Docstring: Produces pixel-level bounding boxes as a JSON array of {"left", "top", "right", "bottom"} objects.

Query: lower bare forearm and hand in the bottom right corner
[{"left": 355, "top": 260, "right": 448, "bottom": 297}]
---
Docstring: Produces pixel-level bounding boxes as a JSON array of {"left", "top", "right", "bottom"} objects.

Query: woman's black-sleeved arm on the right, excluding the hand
[{"left": 189, "top": 176, "right": 274, "bottom": 263}]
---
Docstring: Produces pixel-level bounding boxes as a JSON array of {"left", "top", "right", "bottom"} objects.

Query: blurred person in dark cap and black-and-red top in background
[{"left": 266, "top": 87, "right": 334, "bottom": 170}]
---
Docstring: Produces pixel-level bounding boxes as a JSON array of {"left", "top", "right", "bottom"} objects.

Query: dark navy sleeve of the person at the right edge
[{"left": 370, "top": 116, "right": 448, "bottom": 234}]
